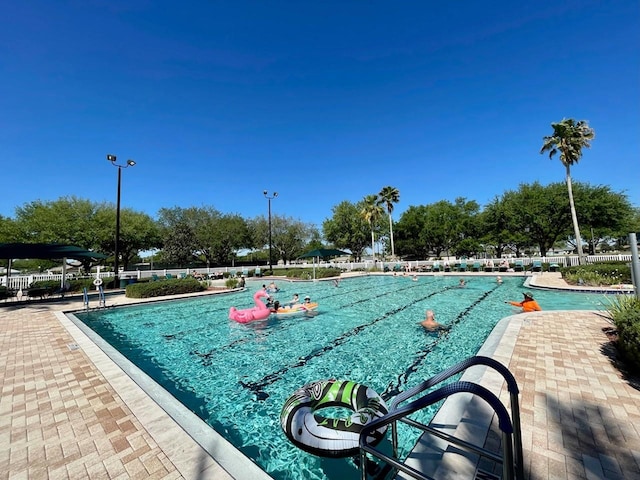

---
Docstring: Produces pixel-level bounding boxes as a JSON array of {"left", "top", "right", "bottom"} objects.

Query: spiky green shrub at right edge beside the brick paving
[{"left": 607, "top": 295, "right": 640, "bottom": 372}]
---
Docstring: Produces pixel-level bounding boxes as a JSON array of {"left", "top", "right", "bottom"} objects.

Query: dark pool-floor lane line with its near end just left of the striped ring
[{"left": 240, "top": 285, "right": 458, "bottom": 400}]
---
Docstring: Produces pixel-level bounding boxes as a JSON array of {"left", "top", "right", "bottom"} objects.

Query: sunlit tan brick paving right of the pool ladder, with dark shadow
[{"left": 508, "top": 312, "right": 640, "bottom": 479}]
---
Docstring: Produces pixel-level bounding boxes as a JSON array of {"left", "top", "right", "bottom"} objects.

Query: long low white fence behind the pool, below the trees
[{"left": 0, "top": 254, "right": 631, "bottom": 291}]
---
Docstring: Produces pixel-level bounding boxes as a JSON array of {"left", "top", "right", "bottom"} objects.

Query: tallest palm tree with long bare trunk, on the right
[{"left": 540, "top": 118, "right": 595, "bottom": 265}]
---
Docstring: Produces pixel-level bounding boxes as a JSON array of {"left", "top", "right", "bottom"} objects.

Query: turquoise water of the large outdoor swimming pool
[{"left": 76, "top": 276, "right": 604, "bottom": 480}]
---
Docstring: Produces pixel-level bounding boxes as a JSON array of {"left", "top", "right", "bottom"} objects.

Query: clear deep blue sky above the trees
[{"left": 0, "top": 0, "right": 640, "bottom": 226}]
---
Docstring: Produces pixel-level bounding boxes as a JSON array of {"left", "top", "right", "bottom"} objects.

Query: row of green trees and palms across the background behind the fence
[{"left": 0, "top": 119, "right": 640, "bottom": 269}]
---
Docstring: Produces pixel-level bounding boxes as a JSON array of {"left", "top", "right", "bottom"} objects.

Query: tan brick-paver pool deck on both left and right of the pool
[{"left": 0, "top": 273, "right": 640, "bottom": 480}]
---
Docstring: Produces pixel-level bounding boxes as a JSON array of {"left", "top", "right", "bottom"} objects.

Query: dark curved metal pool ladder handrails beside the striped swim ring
[{"left": 359, "top": 356, "right": 524, "bottom": 480}]
